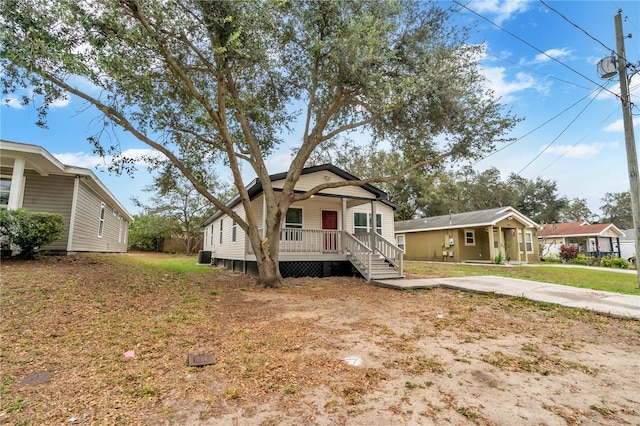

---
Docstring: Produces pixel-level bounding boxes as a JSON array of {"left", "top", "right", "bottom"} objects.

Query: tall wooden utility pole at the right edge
[{"left": 614, "top": 10, "right": 640, "bottom": 289}]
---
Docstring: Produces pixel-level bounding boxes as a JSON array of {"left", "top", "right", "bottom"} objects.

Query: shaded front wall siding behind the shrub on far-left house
[{"left": 22, "top": 170, "right": 74, "bottom": 251}]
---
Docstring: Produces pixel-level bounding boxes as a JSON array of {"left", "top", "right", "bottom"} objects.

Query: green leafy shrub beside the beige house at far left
[{"left": 0, "top": 209, "right": 64, "bottom": 259}]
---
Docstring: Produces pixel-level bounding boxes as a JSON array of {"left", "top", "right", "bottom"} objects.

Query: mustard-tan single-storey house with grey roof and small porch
[{"left": 395, "top": 207, "right": 540, "bottom": 263}]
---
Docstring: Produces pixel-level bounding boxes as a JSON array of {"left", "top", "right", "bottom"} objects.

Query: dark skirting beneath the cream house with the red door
[{"left": 211, "top": 258, "right": 361, "bottom": 278}]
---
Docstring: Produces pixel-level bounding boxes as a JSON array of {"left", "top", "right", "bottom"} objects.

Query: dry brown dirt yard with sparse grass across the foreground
[{"left": 0, "top": 256, "right": 640, "bottom": 425}]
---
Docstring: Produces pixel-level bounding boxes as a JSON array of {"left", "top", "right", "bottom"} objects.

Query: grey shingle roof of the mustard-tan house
[{"left": 395, "top": 206, "right": 538, "bottom": 233}]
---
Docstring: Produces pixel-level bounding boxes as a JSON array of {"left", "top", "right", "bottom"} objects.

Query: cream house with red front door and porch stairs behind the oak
[{"left": 202, "top": 164, "right": 402, "bottom": 280}]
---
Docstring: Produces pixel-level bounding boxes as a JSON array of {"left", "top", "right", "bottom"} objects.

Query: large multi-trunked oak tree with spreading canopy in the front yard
[{"left": 0, "top": 0, "right": 515, "bottom": 286}]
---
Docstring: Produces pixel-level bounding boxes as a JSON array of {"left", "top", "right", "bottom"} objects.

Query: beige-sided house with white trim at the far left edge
[{"left": 0, "top": 140, "right": 133, "bottom": 254}]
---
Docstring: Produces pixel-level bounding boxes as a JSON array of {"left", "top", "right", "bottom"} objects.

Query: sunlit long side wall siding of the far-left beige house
[{"left": 71, "top": 179, "right": 129, "bottom": 252}]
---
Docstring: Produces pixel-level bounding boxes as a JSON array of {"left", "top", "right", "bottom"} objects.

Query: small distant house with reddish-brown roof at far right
[{"left": 538, "top": 222, "right": 624, "bottom": 257}]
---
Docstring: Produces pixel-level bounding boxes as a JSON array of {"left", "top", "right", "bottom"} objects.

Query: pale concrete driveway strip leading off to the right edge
[{"left": 372, "top": 276, "right": 640, "bottom": 320}]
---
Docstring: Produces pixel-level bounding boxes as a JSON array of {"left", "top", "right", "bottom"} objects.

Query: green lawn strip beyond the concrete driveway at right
[{"left": 404, "top": 261, "right": 640, "bottom": 295}]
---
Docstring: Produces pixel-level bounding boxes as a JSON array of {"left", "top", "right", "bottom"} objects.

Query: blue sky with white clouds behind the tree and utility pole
[{"left": 0, "top": 0, "right": 640, "bottom": 218}]
